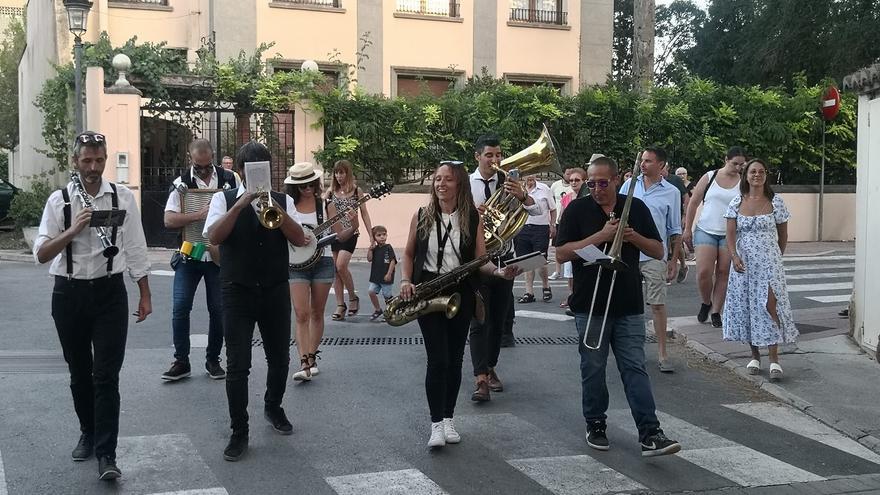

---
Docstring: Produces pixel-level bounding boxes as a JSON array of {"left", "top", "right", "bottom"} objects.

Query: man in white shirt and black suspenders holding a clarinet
[{"left": 33, "top": 131, "right": 153, "bottom": 480}]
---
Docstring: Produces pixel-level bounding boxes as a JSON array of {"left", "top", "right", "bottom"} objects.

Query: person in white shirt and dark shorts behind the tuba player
[{"left": 514, "top": 175, "right": 556, "bottom": 303}]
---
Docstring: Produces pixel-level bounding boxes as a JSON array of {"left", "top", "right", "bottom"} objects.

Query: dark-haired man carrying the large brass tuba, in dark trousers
[{"left": 470, "top": 134, "right": 542, "bottom": 402}]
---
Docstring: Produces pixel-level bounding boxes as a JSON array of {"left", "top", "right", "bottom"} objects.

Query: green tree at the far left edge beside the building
[{"left": 0, "top": 18, "right": 25, "bottom": 150}]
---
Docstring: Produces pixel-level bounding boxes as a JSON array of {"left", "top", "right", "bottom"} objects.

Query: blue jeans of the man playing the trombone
[{"left": 574, "top": 313, "right": 660, "bottom": 441}]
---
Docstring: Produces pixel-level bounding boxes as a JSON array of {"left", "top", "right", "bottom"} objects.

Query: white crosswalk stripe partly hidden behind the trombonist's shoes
[{"left": 608, "top": 409, "right": 825, "bottom": 487}]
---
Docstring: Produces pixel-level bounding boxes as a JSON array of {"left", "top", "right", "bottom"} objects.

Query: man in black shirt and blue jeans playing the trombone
[{"left": 556, "top": 157, "right": 681, "bottom": 457}]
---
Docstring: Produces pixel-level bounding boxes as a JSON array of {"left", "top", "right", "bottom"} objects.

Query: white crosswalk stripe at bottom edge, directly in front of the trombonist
[{"left": 507, "top": 455, "right": 648, "bottom": 495}]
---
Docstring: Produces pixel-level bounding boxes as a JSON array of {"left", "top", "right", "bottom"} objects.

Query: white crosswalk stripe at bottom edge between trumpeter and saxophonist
[{"left": 326, "top": 469, "right": 447, "bottom": 495}]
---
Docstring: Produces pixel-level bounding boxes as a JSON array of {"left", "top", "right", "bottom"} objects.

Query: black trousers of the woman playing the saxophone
[{"left": 419, "top": 284, "right": 475, "bottom": 423}]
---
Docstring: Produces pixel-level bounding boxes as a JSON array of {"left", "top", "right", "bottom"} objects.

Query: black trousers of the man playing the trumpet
[{"left": 223, "top": 281, "right": 290, "bottom": 434}]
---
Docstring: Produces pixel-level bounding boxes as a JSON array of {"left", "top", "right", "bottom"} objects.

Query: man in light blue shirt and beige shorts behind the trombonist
[{"left": 620, "top": 146, "right": 681, "bottom": 373}]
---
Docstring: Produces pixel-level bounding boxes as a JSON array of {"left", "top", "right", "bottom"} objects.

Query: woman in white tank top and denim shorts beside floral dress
[{"left": 682, "top": 146, "right": 746, "bottom": 328}]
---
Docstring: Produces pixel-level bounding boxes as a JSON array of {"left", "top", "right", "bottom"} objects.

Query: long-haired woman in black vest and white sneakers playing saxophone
[{"left": 400, "top": 162, "right": 518, "bottom": 447}]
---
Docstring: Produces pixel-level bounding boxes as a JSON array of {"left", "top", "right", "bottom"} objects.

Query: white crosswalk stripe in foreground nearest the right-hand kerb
[{"left": 724, "top": 402, "right": 880, "bottom": 464}]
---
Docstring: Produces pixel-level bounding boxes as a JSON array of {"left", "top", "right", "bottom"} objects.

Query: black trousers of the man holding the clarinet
[{"left": 52, "top": 273, "right": 128, "bottom": 459}]
